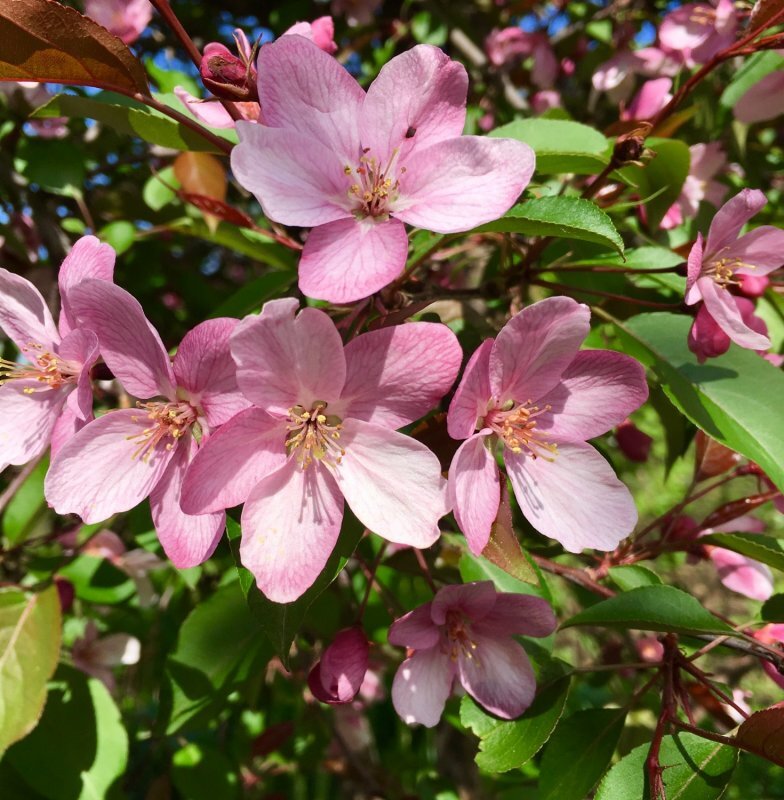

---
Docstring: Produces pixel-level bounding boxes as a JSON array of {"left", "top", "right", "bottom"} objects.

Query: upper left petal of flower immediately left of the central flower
[{"left": 70, "top": 280, "right": 175, "bottom": 398}]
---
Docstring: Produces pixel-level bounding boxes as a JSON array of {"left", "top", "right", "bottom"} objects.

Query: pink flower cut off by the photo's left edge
[{"left": 0, "top": 236, "right": 115, "bottom": 470}]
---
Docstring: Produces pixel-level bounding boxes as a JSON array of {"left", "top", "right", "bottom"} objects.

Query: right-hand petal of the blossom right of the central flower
[{"left": 534, "top": 350, "right": 648, "bottom": 442}]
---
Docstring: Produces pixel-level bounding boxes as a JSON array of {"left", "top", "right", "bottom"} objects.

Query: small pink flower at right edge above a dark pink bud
[{"left": 686, "top": 189, "right": 784, "bottom": 350}]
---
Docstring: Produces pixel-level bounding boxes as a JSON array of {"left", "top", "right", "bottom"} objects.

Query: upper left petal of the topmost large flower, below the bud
[{"left": 257, "top": 36, "right": 365, "bottom": 167}]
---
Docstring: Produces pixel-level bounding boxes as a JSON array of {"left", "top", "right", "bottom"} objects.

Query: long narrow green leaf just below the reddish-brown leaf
[{"left": 33, "top": 92, "right": 230, "bottom": 154}]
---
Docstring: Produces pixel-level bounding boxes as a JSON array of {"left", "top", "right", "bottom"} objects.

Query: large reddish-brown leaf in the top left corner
[{"left": 0, "top": 0, "right": 149, "bottom": 96}]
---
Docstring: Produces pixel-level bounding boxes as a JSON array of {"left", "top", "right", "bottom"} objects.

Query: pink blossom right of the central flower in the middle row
[{"left": 447, "top": 297, "right": 648, "bottom": 553}]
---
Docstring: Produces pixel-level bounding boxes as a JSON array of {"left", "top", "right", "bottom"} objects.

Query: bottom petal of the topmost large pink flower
[{"left": 299, "top": 217, "right": 408, "bottom": 303}]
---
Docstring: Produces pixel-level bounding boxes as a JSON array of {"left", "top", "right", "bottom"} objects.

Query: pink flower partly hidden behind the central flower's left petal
[{"left": 44, "top": 281, "right": 248, "bottom": 568}]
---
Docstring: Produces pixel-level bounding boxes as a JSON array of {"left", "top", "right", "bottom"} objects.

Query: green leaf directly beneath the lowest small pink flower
[{"left": 460, "top": 677, "right": 569, "bottom": 772}]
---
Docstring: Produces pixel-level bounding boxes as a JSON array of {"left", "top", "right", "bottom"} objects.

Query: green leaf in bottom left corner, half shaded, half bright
[{"left": 7, "top": 664, "right": 128, "bottom": 800}]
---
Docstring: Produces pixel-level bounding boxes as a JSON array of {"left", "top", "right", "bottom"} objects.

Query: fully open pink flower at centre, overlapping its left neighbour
[{"left": 182, "top": 299, "right": 461, "bottom": 603}]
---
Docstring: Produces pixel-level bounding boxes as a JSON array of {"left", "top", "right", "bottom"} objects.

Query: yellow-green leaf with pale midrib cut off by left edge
[{"left": 0, "top": 586, "right": 60, "bottom": 754}]
